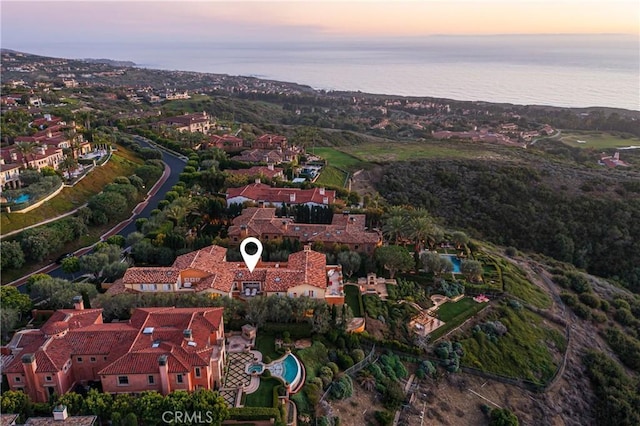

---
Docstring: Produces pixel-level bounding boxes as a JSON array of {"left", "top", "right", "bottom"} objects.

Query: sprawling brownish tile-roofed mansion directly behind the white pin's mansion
[{"left": 229, "top": 207, "right": 382, "bottom": 254}]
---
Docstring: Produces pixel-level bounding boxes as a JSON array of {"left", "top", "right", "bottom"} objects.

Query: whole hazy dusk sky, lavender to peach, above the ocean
[{"left": 0, "top": 0, "right": 640, "bottom": 50}]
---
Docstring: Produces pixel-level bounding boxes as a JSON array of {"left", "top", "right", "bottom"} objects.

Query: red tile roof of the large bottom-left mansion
[{"left": 4, "top": 307, "right": 223, "bottom": 379}]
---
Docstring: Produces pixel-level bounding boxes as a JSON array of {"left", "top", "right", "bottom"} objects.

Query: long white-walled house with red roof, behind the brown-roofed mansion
[{"left": 227, "top": 179, "right": 336, "bottom": 207}]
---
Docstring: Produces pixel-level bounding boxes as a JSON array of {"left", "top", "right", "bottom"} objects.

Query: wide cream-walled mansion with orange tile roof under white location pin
[{"left": 108, "top": 245, "right": 344, "bottom": 304}]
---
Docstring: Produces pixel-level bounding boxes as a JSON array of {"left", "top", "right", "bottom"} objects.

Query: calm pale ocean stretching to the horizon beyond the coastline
[{"left": 16, "top": 35, "right": 640, "bottom": 110}]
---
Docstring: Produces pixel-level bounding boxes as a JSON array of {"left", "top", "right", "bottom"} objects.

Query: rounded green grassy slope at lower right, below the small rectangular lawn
[{"left": 461, "top": 307, "right": 566, "bottom": 383}]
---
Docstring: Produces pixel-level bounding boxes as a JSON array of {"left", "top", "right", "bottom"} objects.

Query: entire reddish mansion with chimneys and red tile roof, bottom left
[{"left": 2, "top": 296, "right": 225, "bottom": 402}]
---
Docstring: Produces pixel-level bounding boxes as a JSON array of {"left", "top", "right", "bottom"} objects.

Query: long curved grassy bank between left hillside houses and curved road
[{"left": 0, "top": 147, "right": 142, "bottom": 233}]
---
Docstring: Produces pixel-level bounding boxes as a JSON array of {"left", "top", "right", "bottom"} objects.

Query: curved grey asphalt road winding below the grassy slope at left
[{"left": 7, "top": 136, "right": 186, "bottom": 291}]
